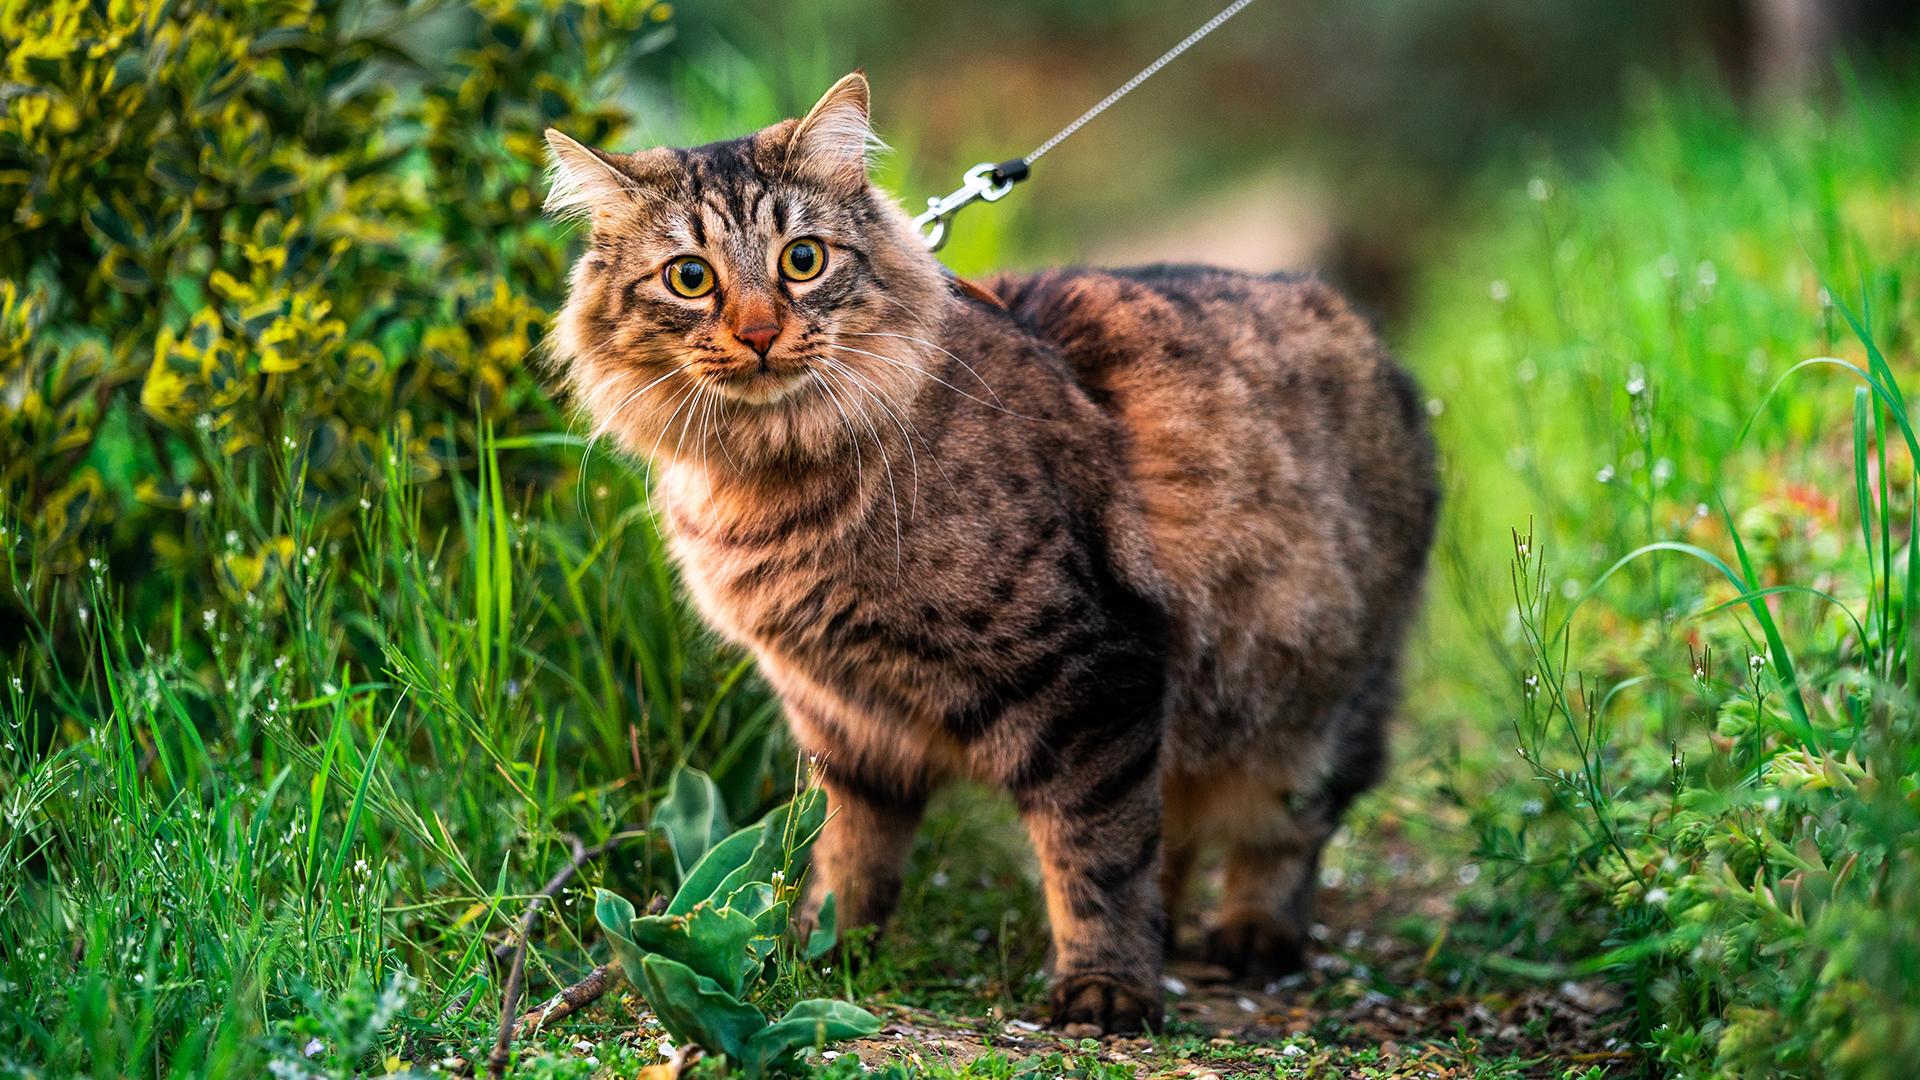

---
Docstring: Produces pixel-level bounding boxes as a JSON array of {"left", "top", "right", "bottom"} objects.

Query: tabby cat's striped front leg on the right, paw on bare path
[{"left": 1016, "top": 724, "right": 1165, "bottom": 1036}]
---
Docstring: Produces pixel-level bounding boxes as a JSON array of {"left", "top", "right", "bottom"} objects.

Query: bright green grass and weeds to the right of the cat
[{"left": 1415, "top": 79, "right": 1920, "bottom": 1076}]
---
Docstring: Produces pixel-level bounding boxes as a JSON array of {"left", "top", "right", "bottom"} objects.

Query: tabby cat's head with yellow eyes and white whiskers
[{"left": 547, "top": 73, "right": 947, "bottom": 463}]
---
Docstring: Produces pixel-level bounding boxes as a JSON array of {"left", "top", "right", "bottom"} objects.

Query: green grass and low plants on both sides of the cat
[{"left": 11, "top": 46, "right": 1920, "bottom": 1078}]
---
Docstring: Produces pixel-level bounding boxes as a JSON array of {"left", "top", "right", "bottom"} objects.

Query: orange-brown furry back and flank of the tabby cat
[{"left": 991, "top": 265, "right": 1436, "bottom": 749}]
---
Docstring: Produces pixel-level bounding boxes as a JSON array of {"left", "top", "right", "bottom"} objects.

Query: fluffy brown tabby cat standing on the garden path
[{"left": 547, "top": 73, "right": 1438, "bottom": 1034}]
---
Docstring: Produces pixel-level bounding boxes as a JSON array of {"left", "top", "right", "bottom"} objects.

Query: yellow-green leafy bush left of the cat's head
[{"left": 0, "top": 0, "right": 668, "bottom": 613}]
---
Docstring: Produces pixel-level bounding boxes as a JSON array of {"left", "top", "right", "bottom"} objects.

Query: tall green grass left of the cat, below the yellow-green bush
[{"left": 0, "top": 417, "right": 785, "bottom": 1074}]
